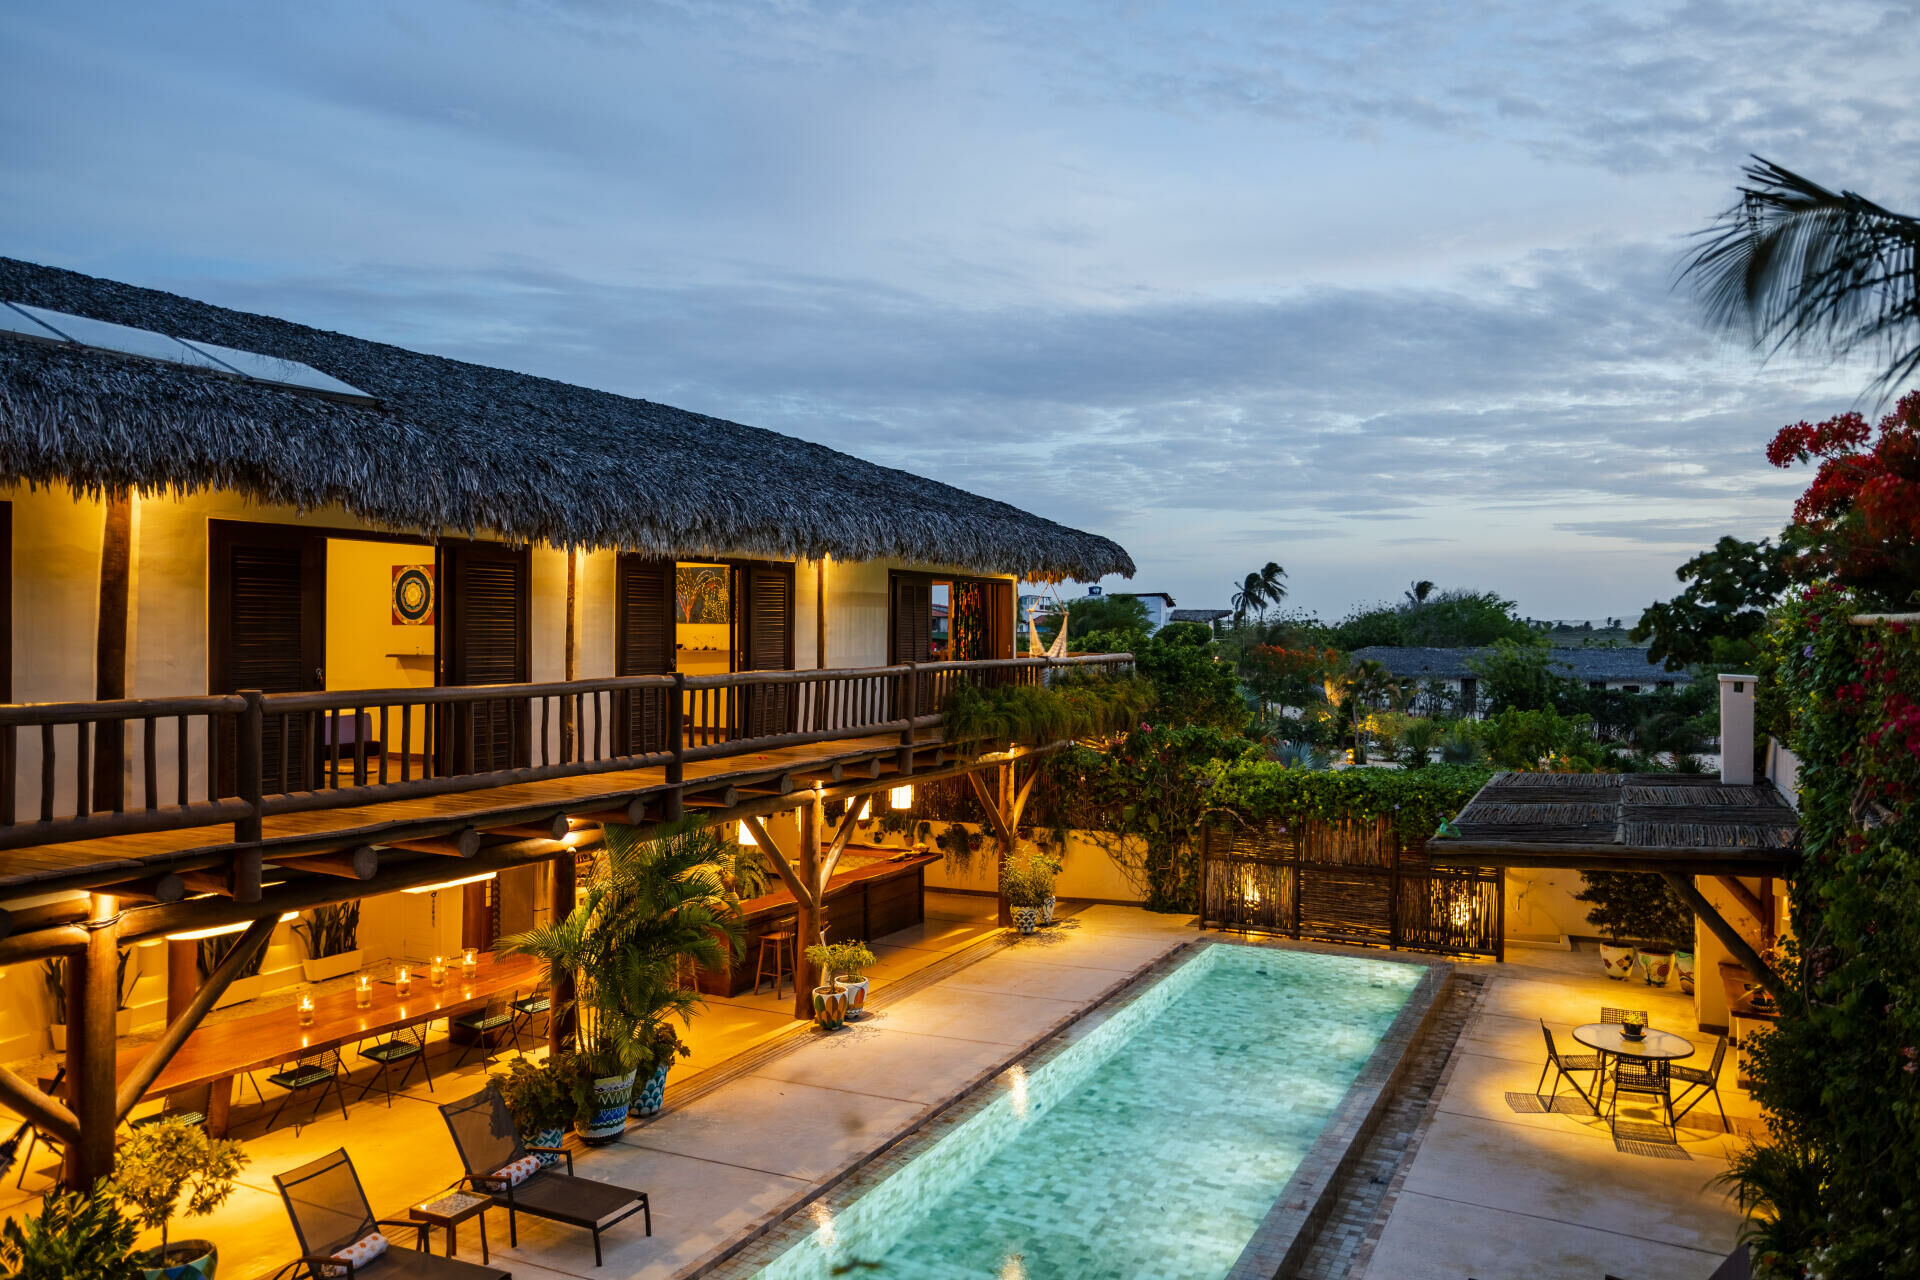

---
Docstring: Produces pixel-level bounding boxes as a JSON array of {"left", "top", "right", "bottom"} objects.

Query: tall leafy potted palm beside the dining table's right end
[{"left": 503, "top": 819, "right": 745, "bottom": 1088}]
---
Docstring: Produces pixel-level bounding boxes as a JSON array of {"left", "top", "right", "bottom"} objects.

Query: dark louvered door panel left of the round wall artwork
[{"left": 207, "top": 520, "right": 326, "bottom": 794}]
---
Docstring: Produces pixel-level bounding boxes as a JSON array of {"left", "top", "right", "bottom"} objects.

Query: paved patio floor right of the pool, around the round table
[{"left": 1354, "top": 944, "right": 1759, "bottom": 1280}]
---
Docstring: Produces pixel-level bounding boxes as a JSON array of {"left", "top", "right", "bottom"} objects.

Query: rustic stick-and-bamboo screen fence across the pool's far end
[{"left": 1200, "top": 818, "right": 1505, "bottom": 960}]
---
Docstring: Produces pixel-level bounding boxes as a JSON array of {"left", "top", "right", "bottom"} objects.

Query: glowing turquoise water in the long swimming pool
[{"left": 758, "top": 944, "right": 1423, "bottom": 1280}]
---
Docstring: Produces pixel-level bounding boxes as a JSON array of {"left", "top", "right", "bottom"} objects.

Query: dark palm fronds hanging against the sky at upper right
[{"left": 1680, "top": 155, "right": 1920, "bottom": 390}]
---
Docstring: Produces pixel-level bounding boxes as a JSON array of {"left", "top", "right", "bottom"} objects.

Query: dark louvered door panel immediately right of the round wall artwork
[{"left": 436, "top": 541, "right": 532, "bottom": 773}]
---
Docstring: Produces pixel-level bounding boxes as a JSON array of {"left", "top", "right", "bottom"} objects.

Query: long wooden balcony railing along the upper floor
[{"left": 0, "top": 654, "right": 1133, "bottom": 850}]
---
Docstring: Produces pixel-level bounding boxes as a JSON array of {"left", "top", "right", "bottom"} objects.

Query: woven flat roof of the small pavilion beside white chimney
[{"left": 1427, "top": 773, "right": 1799, "bottom": 875}]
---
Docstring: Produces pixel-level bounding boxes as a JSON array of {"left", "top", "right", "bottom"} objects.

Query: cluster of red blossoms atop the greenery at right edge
[{"left": 1766, "top": 391, "right": 1920, "bottom": 595}]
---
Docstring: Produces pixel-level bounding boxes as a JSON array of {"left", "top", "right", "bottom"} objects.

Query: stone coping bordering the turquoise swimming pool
[{"left": 698, "top": 935, "right": 1452, "bottom": 1280}]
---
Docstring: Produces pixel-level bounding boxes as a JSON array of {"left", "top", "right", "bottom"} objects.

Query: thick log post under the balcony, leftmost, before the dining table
[{"left": 61, "top": 894, "right": 119, "bottom": 1192}]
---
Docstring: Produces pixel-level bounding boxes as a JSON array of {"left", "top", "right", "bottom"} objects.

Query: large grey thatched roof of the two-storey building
[{"left": 0, "top": 257, "right": 1133, "bottom": 580}]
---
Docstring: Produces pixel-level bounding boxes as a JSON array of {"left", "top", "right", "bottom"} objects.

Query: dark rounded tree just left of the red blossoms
[{"left": 1632, "top": 537, "right": 1788, "bottom": 672}]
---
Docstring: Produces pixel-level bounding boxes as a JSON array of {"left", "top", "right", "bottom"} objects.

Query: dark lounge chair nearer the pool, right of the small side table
[{"left": 440, "top": 1084, "right": 653, "bottom": 1267}]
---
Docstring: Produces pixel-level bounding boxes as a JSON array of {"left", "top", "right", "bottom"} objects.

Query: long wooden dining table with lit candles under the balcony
[{"left": 40, "top": 952, "right": 543, "bottom": 1138}]
